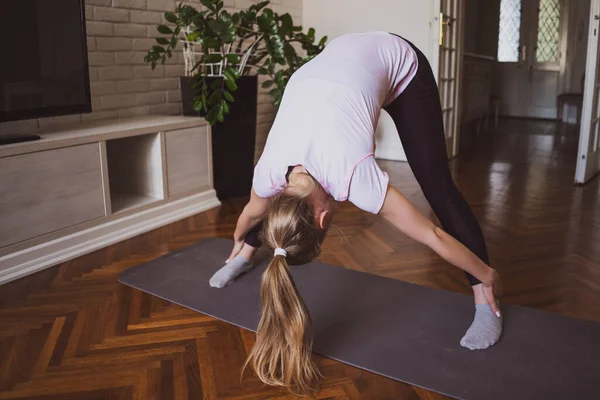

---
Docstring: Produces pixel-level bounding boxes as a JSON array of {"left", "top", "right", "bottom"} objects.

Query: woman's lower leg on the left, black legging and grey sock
[{"left": 209, "top": 222, "right": 262, "bottom": 289}]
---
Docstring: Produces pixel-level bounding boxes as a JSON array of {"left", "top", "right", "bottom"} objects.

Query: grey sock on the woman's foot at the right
[{"left": 460, "top": 304, "right": 502, "bottom": 350}]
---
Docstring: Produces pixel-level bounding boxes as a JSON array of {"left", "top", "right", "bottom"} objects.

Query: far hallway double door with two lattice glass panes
[{"left": 498, "top": 0, "right": 567, "bottom": 119}]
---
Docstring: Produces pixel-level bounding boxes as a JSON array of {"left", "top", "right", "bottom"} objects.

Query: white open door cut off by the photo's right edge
[{"left": 575, "top": 0, "right": 600, "bottom": 184}]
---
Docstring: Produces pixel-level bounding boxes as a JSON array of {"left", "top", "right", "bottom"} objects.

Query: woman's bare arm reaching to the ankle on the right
[{"left": 380, "top": 186, "right": 496, "bottom": 286}]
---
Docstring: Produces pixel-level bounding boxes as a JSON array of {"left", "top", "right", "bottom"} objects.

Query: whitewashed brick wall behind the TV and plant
[{"left": 0, "top": 0, "right": 302, "bottom": 159}]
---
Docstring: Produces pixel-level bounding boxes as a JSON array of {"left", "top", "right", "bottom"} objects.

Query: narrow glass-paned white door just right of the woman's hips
[{"left": 438, "top": 0, "right": 464, "bottom": 157}]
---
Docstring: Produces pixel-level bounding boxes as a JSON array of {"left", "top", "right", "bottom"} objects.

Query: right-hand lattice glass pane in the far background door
[{"left": 535, "top": 0, "right": 560, "bottom": 63}]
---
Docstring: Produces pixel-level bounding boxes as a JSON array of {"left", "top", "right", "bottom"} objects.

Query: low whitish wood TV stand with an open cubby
[{"left": 0, "top": 116, "right": 220, "bottom": 284}]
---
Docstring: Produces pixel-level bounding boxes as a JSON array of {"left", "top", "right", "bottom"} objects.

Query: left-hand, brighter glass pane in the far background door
[{"left": 498, "top": 0, "right": 521, "bottom": 62}]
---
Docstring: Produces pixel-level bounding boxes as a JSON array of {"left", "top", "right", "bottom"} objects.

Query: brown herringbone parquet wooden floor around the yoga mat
[{"left": 0, "top": 120, "right": 600, "bottom": 400}]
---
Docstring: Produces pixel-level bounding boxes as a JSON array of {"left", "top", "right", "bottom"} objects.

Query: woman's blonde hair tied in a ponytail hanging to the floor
[{"left": 244, "top": 194, "right": 324, "bottom": 395}]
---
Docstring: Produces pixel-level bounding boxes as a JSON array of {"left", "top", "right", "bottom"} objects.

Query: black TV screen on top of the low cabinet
[{"left": 0, "top": 0, "right": 91, "bottom": 121}]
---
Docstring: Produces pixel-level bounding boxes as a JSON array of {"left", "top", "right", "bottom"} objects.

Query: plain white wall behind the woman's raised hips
[{"left": 302, "top": 0, "right": 439, "bottom": 161}]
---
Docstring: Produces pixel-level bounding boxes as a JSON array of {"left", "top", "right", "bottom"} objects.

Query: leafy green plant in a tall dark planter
[{"left": 145, "top": 0, "right": 327, "bottom": 200}]
